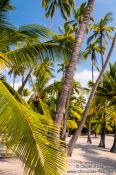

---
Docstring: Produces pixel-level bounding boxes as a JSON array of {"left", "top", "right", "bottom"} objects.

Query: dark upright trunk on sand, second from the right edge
[{"left": 99, "top": 113, "right": 106, "bottom": 148}]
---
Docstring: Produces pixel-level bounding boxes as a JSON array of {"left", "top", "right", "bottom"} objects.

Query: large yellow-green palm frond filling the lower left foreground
[{"left": 0, "top": 81, "right": 66, "bottom": 175}]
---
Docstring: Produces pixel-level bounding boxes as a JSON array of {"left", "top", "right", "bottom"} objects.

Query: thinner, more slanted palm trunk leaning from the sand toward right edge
[{"left": 68, "top": 34, "right": 116, "bottom": 156}]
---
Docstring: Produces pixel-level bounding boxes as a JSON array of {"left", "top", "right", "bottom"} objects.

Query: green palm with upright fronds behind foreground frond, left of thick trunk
[{"left": 28, "top": 58, "right": 53, "bottom": 114}]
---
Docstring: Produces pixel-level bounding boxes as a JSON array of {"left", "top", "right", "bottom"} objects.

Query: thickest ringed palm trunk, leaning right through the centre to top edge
[{"left": 55, "top": 0, "right": 95, "bottom": 133}]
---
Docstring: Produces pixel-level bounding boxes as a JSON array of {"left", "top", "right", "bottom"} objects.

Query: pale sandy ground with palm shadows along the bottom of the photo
[{"left": 0, "top": 136, "right": 116, "bottom": 175}]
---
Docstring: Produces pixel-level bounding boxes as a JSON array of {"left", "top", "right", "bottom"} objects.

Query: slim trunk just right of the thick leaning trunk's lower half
[{"left": 61, "top": 85, "right": 72, "bottom": 141}]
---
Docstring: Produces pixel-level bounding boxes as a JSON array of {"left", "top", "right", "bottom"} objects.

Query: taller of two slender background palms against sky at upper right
[{"left": 88, "top": 13, "right": 115, "bottom": 66}]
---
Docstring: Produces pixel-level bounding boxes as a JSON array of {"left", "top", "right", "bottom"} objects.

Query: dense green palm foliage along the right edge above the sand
[{"left": 92, "top": 63, "right": 116, "bottom": 133}]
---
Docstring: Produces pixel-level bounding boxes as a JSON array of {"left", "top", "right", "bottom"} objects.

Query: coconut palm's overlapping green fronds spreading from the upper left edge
[{"left": 0, "top": 0, "right": 74, "bottom": 71}]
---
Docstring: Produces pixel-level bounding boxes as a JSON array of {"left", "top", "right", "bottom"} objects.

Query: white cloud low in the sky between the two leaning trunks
[{"left": 74, "top": 70, "right": 99, "bottom": 87}]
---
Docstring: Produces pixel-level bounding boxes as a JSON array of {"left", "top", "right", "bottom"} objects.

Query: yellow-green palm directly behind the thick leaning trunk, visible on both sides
[{"left": 44, "top": 79, "right": 85, "bottom": 140}]
